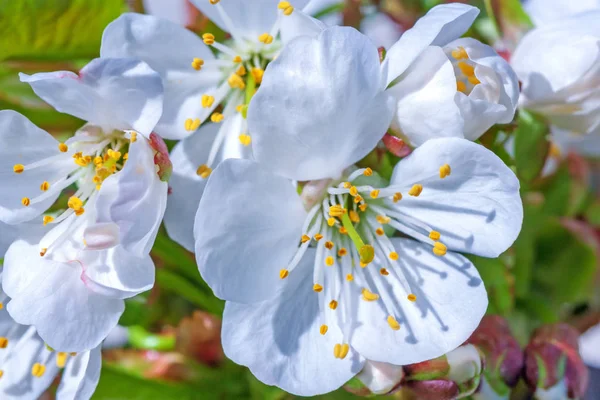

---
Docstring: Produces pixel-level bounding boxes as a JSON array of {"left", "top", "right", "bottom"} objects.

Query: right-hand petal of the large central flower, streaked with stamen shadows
[{"left": 391, "top": 138, "right": 523, "bottom": 257}]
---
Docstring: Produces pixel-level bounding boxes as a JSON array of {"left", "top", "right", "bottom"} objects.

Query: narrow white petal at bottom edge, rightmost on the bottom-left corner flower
[{"left": 56, "top": 346, "right": 102, "bottom": 400}]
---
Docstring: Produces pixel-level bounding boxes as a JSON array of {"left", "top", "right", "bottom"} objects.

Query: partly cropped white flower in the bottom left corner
[{"left": 0, "top": 273, "right": 101, "bottom": 400}]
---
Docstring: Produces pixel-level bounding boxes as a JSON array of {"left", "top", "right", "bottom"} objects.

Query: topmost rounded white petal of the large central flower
[{"left": 248, "top": 27, "right": 393, "bottom": 180}]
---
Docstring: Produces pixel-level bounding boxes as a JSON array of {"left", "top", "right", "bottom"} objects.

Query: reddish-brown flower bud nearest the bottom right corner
[{"left": 524, "top": 324, "right": 588, "bottom": 400}]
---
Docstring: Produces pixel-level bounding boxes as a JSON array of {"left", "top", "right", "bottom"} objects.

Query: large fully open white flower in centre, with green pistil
[{"left": 194, "top": 28, "right": 522, "bottom": 395}]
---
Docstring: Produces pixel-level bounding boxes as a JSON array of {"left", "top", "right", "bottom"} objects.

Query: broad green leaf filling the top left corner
[{"left": 0, "top": 0, "right": 124, "bottom": 60}]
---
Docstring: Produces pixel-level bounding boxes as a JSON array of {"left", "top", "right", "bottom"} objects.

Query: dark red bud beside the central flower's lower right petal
[{"left": 467, "top": 315, "right": 523, "bottom": 399}]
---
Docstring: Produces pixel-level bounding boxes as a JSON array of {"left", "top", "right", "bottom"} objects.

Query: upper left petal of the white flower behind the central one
[{"left": 100, "top": 13, "right": 222, "bottom": 139}]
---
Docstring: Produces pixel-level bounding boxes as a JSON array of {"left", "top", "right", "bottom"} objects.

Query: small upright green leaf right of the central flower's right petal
[{"left": 515, "top": 111, "right": 550, "bottom": 182}]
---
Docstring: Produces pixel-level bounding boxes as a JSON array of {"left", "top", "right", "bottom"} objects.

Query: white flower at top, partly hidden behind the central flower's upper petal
[{"left": 101, "top": 0, "right": 318, "bottom": 250}]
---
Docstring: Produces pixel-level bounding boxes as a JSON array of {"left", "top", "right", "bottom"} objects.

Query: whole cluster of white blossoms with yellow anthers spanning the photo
[{"left": 0, "top": 0, "right": 600, "bottom": 400}]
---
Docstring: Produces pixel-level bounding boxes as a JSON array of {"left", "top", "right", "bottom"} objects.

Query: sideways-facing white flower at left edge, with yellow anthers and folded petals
[{"left": 0, "top": 59, "right": 170, "bottom": 351}]
